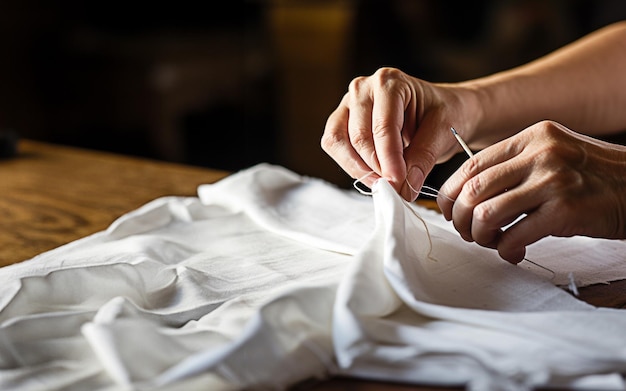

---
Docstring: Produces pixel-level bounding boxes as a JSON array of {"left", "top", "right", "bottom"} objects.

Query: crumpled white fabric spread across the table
[{"left": 0, "top": 165, "right": 626, "bottom": 390}]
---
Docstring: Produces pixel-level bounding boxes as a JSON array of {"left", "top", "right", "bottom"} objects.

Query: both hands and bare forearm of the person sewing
[{"left": 321, "top": 22, "right": 626, "bottom": 263}]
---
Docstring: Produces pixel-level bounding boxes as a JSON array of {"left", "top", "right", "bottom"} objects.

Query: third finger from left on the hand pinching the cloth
[{"left": 372, "top": 75, "right": 415, "bottom": 190}]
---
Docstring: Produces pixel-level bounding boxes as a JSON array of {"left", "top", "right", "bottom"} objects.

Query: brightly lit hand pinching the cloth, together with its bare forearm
[{"left": 321, "top": 22, "right": 626, "bottom": 204}]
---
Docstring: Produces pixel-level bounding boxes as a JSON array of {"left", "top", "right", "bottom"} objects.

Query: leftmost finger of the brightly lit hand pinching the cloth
[{"left": 321, "top": 94, "right": 380, "bottom": 187}]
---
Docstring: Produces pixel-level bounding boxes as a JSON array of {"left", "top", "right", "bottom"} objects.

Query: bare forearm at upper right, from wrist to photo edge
[{"left": 458, "top": 22, "right": 626, "bottom": 148}]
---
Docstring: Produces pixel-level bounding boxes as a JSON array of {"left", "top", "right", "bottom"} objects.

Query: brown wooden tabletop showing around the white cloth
[{"left": 0, "top": 141, "right": 626, "bottom": 391}]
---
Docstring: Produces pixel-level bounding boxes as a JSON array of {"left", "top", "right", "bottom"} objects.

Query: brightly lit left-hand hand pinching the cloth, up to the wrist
[{"left": 322, "top": 68, "right": 478, "bottom": 201}]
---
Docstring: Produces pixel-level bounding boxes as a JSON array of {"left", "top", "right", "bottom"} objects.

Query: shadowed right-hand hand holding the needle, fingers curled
[{"left": 437, "top": 121, "right": 626, "bottom": 263}]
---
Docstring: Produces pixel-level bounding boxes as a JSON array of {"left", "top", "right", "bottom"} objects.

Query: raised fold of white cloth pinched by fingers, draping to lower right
[{"left": 333, "top": 181, "right": 626, "bottom": 390}]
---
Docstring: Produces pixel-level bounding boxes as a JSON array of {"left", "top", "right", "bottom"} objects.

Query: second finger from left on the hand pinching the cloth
[{"left": 347, "top": 77, "right": 382, "bottom": 175}]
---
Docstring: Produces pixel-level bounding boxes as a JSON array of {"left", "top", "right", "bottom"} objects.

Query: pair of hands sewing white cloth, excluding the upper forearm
[{"left": 322, "top": 69, "right": 626, "bottom": 263}]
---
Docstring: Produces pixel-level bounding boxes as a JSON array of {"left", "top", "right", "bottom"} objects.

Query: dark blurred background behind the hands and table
[{"left": 0, "top": 0, "right": 626, "bottom": 190}]
